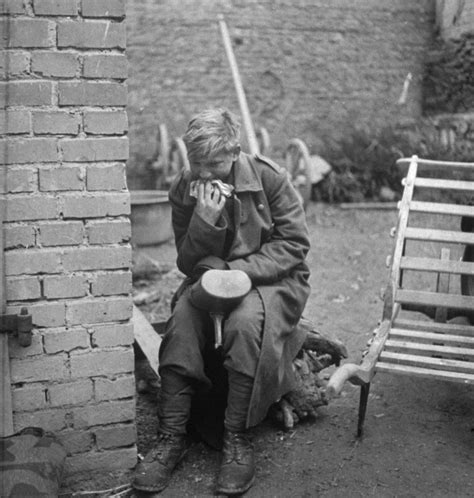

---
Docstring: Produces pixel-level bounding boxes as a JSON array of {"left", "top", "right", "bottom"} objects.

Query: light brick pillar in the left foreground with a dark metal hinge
[{"left": 0, "top": 0, "right": 136, "bottom": 473}]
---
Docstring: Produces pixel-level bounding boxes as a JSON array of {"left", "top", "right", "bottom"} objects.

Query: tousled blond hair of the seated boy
[{"left": 183, "top": 107, "right": 240, "bottom": 161}]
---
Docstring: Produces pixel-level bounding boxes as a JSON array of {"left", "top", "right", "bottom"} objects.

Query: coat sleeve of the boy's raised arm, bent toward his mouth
[{"left": 169, "top": 175, "right": 230, "bottom": 277}]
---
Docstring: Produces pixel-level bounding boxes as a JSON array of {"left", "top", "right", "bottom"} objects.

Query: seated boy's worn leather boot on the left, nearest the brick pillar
[{"left": 132, "top": 434, "right": 189, "bottom": 493}]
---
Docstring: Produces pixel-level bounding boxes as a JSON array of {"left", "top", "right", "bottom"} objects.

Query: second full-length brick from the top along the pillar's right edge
[{"left": 58, "top": 81, "right": 127, "bottom": 106}]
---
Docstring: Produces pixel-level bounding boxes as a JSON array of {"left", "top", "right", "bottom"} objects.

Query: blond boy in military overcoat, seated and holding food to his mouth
[{"left": 134, "top": 109, "right": 310, "bottom": 495}]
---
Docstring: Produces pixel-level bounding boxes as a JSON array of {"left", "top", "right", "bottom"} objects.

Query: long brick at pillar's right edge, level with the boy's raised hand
[{"left": 62, "top": 194, "right": 130, "bottom": 218}]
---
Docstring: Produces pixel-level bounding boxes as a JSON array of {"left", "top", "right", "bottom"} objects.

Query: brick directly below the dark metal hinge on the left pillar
[{"left": 11, "top": 354, "right": 70, "bottom": 384}]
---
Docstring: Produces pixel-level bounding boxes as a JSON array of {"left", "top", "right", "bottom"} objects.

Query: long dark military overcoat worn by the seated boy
[{"left": 169, "top": 153, "right": 310, "bottom": 427}]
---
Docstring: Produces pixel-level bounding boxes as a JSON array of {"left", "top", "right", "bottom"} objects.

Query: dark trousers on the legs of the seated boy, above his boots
[{"left": 158, "top": 290, "right": 264, "bottom": 434}]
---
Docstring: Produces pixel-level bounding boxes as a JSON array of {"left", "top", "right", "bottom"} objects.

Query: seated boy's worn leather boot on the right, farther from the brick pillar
[{"left": 216, "top": 430, "right": 255, "bottom": 496}]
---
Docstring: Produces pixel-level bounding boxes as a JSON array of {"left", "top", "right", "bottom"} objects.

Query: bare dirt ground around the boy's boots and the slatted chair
[{"left": 64, "top": 204, "right": 474, "bottom": 498}]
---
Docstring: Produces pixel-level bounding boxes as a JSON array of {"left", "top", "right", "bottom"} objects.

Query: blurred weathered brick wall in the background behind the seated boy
[{"left": 127, "top": 0, "right": 435, "bottom": 187}]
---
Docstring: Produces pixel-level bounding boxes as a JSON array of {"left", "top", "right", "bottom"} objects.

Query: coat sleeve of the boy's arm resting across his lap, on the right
[{"left": 228, "top": 168, "right": 310, "bottom": 285}]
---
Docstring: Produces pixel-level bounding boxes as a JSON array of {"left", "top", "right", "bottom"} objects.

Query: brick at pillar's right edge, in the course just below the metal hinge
[{"left": 70, "top": 348, "right": 135, "bottom": 376}]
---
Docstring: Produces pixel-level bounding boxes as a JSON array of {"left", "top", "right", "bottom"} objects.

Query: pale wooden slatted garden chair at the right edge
[{"left": 326, "top": 156, "right": 474, "bottom": 436}]
